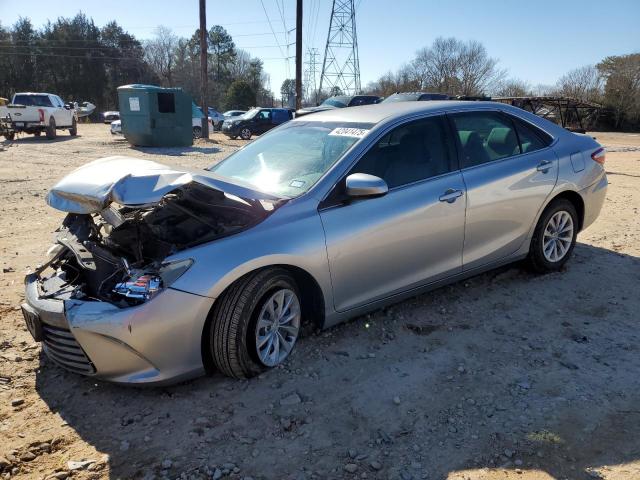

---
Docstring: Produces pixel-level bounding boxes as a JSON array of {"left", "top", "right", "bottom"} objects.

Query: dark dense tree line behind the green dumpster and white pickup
[{"left": 0, "top": 13, "right": 273, "bottom": 115}]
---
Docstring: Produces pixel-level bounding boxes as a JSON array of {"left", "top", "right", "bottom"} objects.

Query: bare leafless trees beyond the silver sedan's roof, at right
[{"left": 365, "top": 37, "right": 640, "bottom": 129}]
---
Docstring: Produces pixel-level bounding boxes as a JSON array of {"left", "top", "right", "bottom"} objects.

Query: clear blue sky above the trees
[{"left": 0, "top": 0, "right": 640, "bottom": 94}]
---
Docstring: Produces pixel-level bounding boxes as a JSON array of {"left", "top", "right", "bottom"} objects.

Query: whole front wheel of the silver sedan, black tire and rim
[{"left": 207, "top": 268, "right": 301, "bottom": 378}]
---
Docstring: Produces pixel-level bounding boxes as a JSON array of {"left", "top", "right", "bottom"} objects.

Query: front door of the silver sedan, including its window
[{"left": 320, "top": 117, "right": 466, "bottom": 311}]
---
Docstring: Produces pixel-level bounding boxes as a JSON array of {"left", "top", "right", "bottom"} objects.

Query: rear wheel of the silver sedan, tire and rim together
[{"left": 527, "top": 198, "right": 579, "bottom": 273}]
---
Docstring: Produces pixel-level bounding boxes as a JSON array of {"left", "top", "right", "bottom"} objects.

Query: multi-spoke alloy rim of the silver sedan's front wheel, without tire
[{"left": 255, "top": 288, "right": 301, "bottom": 367}]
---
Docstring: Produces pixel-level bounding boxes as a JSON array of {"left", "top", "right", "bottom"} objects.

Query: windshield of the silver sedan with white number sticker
[{"left": 209, "top": 121, "right": 373, "bottom": 198}]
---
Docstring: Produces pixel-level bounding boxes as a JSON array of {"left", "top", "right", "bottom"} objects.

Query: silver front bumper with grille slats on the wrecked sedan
[{"left": 22, "top": 275, "right": 213, "bottom": 385}]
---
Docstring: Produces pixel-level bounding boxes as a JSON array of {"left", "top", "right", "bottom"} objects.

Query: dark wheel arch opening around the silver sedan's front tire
[{"left": 200, "top": 263, "right": 325, "bottom": 373}]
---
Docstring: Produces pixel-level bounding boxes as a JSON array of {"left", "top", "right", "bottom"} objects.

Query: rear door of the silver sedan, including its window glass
[{"left": 449, "top": 110, "right": 558, "bottom": 270}]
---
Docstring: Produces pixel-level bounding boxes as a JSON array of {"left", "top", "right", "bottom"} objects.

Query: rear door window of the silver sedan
[{"left": 451, "top": 112, "right": 520, "bottom": 168}]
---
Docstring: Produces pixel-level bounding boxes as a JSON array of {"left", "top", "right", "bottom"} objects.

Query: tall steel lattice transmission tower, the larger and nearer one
[{"left": 320, "top": 0, "right": 360, "bottom": 94}]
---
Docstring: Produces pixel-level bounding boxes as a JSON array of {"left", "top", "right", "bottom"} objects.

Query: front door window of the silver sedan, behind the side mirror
[{"left": 350, "top": 116, "right": 454, "bottom": 188}]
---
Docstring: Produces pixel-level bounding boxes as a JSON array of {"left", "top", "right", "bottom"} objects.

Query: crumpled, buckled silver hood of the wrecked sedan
[{"left": 47, "top": 156, "right": 279, "bottom": 214}]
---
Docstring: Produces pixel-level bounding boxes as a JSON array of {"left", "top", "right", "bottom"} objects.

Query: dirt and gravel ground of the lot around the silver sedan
[{"left": 0, "top": 125, "right": 640, "bottom": 480}]
